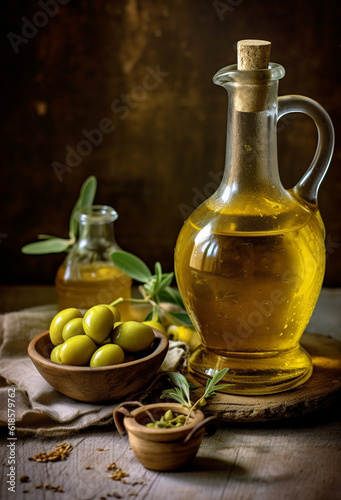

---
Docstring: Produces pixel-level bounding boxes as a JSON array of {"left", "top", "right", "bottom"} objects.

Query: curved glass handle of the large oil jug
[{"left": 278, "top": 95, "right": 335, "bottom": 206}]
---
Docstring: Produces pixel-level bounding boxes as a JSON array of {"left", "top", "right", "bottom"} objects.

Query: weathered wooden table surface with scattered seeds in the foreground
[{"left": 1, "top": 288, "right": 341, "bottom": 500}]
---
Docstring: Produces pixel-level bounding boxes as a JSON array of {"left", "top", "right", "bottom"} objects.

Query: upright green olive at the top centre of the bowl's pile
[{"left": 83, "top": 305, "right": 114, "bottom": 344}]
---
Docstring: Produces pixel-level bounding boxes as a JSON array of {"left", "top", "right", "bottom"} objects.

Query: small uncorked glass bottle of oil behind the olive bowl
[{"left": 55, "top": 205, "right": 132, "bottom": 320}]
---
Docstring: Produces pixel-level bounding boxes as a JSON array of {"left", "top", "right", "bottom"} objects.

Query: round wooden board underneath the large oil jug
[{"left": 188, "top": 333, "right": 341, "bottom": 422}]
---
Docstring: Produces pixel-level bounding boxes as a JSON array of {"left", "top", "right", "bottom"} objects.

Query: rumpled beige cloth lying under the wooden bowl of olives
[{"left": 0, "top": 305, "right": 188, "bottom": 436}]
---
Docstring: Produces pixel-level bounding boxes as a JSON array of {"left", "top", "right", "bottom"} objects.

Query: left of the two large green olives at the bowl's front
[{"left": 58, "top": 335, "right": 97, "bottom": 366}]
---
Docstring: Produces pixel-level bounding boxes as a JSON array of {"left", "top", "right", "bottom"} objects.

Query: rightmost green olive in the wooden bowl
[{"left": 112, "top": 321, "right": 155, "bottom": 352}]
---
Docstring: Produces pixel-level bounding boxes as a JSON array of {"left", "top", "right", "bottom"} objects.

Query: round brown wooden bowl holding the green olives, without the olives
[{"left": 27, "top": 328, "right": 168, "bottom": 403}]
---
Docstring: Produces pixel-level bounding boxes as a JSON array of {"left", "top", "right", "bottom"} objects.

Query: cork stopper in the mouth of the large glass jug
[{"left": 237, "top": 40, "right": 271, "bottom": 70}]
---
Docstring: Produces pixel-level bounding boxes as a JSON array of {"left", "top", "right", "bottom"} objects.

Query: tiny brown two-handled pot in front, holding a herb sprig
[{"left": 114, "top": 401, "right": 216, "bottom": 471}]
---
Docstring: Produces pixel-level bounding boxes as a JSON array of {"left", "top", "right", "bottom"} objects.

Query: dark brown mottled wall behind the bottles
[{"left": 0, "top": 0, "right": 341, "bottom": 286}]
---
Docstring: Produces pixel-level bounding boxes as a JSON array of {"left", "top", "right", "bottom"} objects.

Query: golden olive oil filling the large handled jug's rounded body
[{"left": 175, "top": 204, "right": 325, "bottom": 394}]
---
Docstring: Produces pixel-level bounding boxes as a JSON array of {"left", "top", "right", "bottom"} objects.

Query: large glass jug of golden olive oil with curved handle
[{"left": 175, "top": 41, "right": 334, "bottom": 395}]
